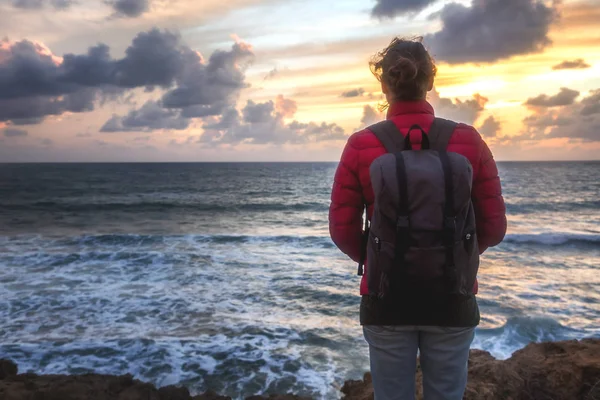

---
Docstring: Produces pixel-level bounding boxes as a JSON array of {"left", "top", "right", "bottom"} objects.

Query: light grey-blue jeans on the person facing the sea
[{"left": 363, "top": 325, "right": 475, "bottom": 400}]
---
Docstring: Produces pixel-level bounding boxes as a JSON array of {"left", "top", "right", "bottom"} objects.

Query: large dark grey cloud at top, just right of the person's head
[{"left": 425, "top": 0, "right": 557, "bottom": 64}]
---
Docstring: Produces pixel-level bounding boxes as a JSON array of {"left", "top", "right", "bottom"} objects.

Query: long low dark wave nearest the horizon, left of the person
[{"left": 0, "top": 201, "right": 329, "bottom": 213}]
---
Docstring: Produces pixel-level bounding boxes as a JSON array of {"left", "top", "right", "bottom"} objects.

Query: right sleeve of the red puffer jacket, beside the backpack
[{"left": 472, "top": 140, "right": 506, "bottom": 253}]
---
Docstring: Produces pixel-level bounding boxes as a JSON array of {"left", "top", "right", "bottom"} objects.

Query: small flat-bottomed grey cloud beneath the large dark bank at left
[{"left": 100, "top": 100, "right": 190, "bottom": 132}]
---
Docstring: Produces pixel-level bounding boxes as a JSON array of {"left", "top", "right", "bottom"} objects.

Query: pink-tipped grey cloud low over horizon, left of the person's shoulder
[{"left": 200, "top": 95, "right": 347, "bottom": 145}]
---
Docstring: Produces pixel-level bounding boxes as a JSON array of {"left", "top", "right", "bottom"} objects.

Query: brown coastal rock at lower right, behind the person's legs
[{"left": 342, "top": 339, "right": 600, "bottom": 400}]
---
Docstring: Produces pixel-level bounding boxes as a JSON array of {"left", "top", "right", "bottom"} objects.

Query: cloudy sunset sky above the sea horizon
[{"left": 0, "top": 0, "right": 600, "bottom": 162}]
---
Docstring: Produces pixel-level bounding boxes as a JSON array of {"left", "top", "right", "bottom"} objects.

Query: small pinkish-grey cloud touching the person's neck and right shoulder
[{"left": 428, "top": 89, "right": 488, "bottom": 125}]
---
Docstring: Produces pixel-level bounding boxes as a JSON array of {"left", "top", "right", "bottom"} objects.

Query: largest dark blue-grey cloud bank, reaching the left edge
[{"left": 0, "top": 29, "right": 253, "bottom": 129}]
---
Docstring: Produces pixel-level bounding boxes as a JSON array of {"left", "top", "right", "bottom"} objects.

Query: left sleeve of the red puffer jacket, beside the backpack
[{"left": 329, "top": 138, "right": 364, "bottom": 262}]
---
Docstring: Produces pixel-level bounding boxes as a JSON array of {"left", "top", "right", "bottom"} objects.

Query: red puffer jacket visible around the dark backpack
[{"left": 329, "top": 100, "right": 506, "bottom": 295}]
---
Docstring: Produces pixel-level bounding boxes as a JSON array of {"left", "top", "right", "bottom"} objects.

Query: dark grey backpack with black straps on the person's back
[{"left": 359, "top": 118, "right": 479, "bottom": 298}]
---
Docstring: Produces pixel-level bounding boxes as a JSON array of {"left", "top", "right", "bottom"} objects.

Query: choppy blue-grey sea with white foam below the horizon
[{"left": 0, "top": 162, "right": 600, "bottom": 399}]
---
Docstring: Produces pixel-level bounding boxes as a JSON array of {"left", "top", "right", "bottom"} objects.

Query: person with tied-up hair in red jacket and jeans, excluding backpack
[{"left": 329, "top": 38, "right": 506, "bottom": 400}]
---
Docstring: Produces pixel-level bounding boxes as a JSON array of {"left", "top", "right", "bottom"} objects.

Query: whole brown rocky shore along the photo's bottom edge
[{"left": 0, "top": 339, "right": 600, "bottom": 400}]
